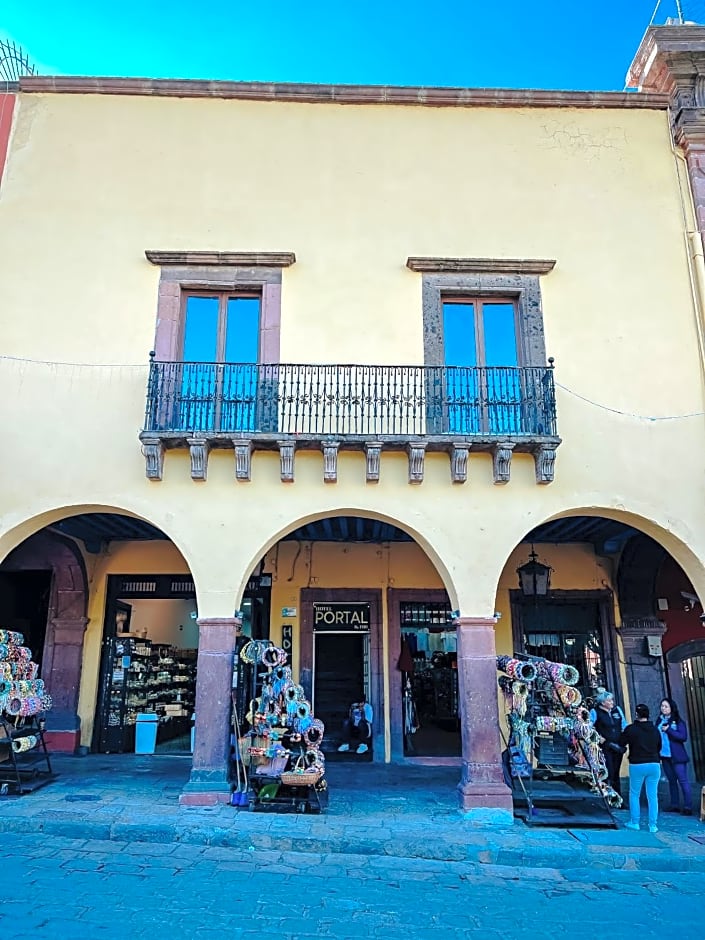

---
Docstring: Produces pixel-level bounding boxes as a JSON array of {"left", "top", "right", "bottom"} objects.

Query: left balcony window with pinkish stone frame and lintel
[{"left": 147, "top": 251, "right": 295, "bottom": 434}]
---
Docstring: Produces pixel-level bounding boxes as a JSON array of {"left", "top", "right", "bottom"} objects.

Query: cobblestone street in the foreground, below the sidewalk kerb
[{"left": 0, "top": 833, "right": 703, "bottom": 940}]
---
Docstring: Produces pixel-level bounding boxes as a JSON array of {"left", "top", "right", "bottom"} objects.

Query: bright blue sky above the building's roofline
[{"left": 0, "top": 0, "right": 705, "bottom": 90}]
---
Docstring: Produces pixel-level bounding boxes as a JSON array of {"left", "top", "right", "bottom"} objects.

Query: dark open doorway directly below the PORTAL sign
[{"left": 312, "top": 633, "right": 370, "bottom": 752}]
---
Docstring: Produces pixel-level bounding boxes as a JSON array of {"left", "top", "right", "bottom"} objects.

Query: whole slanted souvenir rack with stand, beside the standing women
[{"left": 497, "top": 654, "right": 622, "bottom": 821}]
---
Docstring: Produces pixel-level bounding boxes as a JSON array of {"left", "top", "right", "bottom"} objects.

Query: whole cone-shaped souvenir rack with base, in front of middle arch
[{"left": 231, "top": 640, "right": 328, "bottom": 813}]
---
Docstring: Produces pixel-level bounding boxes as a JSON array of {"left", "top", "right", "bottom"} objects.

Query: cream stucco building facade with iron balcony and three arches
[{"left": 0, "top": 27, "right": 705, "bottom": 809}]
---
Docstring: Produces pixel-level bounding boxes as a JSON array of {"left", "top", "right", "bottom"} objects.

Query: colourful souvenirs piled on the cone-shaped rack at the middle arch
[{"left": 234, "top": 640, "right": 325, "bottom": 805}]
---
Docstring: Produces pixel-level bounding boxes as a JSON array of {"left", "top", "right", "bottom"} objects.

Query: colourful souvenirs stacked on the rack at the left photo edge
[{"left": 0, "top": 630, "right": 51, "bottom": 732}]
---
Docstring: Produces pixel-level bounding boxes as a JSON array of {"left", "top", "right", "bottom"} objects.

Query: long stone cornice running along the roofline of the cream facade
[{"left": 20, "top": 75, "right": 668, "bottom": 110}]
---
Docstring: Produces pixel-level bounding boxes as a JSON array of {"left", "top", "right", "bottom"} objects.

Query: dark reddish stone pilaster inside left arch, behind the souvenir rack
[{"left": 43, "top": 617, "right": 88, "bottom": 754}]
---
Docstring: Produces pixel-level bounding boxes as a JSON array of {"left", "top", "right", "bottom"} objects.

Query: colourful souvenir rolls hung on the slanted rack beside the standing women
[{"left": 497, "top": 656, "right": 622, "bottom": 808}]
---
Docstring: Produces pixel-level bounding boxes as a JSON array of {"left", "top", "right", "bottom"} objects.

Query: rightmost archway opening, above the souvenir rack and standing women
[{"left": 497, "top": 515, "right": 705, "bottom": 774}]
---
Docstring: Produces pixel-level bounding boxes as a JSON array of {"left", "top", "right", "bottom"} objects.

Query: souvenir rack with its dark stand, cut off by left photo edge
[{"left": 0, "top": 630, "right": 54, "bottom": 796}]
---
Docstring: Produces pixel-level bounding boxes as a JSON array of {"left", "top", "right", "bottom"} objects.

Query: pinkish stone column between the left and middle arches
[{"left": 179, "top": 617, "right": 242, "bottom": 806}]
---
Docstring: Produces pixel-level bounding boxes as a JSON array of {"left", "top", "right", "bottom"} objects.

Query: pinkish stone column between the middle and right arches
[{"left": 455, "top": 617, "right": 513, "bottom": 824}]
